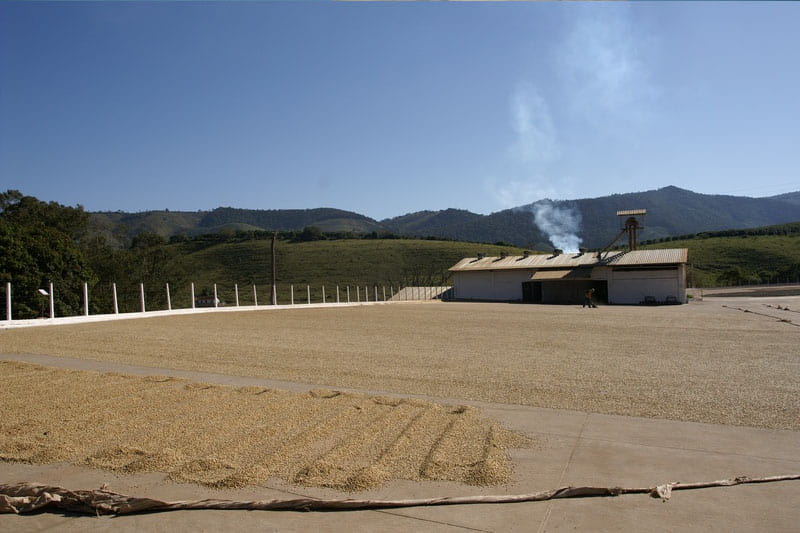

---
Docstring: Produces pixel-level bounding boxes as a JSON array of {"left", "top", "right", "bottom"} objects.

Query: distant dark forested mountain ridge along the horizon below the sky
[{"left": 87, "top": 186, "right": 800, "bottom": 250}]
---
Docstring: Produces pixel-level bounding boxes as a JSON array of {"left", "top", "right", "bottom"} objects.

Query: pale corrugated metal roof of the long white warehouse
[{"left": 450, "top": 248, "right": 688, "bottom": 272}]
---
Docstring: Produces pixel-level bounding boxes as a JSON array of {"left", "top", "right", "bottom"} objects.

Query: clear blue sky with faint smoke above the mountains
[{"left": 0, "top": 2, "right": 800, "bottom": 219}]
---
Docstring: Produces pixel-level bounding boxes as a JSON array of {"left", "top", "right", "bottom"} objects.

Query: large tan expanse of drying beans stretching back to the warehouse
[{"left": 0, "top": 301, "right": 800, "bottom": 429}]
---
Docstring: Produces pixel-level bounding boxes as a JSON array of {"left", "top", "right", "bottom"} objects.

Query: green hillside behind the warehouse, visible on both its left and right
[{"left": 98, "top": 229, "right": 800, "bottom": 312}]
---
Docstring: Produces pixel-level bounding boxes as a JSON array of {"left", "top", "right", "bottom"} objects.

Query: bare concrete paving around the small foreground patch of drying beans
[{"left": 0, "top": 356, "right": 800, "bottom": 531}]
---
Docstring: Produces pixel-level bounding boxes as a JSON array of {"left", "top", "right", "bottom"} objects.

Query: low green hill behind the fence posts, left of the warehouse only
[{"left": 93, "top": 239, "right": 522, "bottom": 312}]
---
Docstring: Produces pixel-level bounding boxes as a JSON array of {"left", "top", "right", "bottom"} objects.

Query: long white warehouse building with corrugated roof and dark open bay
[{"left": 450, "top": 248, "right": 688, "bottom": 304}]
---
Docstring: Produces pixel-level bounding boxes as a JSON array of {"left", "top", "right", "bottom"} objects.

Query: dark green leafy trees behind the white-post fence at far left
[{"left": 0, "top": 190, "right": 186, "bottom": 318}]
